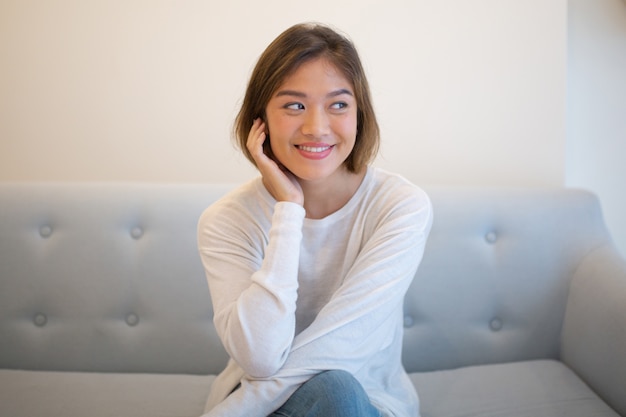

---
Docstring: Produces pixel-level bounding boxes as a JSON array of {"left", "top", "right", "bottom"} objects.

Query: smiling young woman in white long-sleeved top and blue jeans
[{"left": 198, "top": 24, "right": 432, "bottom": 417}]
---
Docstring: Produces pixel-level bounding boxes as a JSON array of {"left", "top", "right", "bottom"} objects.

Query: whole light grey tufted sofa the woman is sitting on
[{"left": 0, "top": 184, "right": 626, "bottom": 417}]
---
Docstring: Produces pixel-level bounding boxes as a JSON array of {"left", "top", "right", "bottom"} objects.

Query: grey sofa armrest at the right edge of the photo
[{"left": 561, "top": 245, "right": 626, "bottom": 416}]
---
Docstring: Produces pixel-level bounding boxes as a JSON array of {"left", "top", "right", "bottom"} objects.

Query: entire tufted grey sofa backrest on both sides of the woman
[{"left": 0, "top": 184, "right": 609, "bottom": 374}]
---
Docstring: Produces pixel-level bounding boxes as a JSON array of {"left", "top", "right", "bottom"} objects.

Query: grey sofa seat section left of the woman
[{"left": 0, "top": 370, "right": 214, "bottom": 417}]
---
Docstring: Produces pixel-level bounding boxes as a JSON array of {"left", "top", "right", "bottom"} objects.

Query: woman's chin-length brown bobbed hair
[{"left": 233, "top": 23, "right": 380, "bottom": 172}]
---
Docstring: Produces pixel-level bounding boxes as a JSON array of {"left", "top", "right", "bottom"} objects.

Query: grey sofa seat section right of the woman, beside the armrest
[{"left": 410, "top": 360, "right": 619, "bottom": 417}]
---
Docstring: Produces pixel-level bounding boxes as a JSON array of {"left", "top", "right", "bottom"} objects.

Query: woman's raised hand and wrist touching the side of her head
[{"left": 246, "top": 119, "right": 304, "bottom": 205}]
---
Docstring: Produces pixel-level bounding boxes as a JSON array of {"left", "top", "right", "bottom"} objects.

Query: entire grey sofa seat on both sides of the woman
[{"left": 0, "top": 360, "right": 619, "bottom": 417}]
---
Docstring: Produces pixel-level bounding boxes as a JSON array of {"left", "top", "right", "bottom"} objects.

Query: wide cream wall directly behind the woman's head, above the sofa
[{"left": 0, "top": 0, "right": 567, "bottom": 185}]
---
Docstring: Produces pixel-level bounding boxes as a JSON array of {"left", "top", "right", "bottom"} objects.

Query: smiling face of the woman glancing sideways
[{"left": 265, "top": 58, "right": 357, "bottom": 181}]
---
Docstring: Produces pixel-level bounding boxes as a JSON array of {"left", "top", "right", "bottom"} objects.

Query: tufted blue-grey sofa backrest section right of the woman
[{"left": 403, "top": 187, "right": 610, "bottom": 372}]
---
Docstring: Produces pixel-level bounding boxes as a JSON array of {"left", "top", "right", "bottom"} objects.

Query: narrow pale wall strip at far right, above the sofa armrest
[{"left": 566, "top": 0, "right": 626, "bottom": 255}]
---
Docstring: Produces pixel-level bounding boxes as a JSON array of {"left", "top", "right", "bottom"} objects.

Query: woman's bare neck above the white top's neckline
[{"left": 299, "top": 168, "right": 367, "bottom": 219}]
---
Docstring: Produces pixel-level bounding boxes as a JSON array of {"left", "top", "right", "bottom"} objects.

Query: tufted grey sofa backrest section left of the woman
[{"left": 0, "top": 184, "right": 230, "bottom": 373}]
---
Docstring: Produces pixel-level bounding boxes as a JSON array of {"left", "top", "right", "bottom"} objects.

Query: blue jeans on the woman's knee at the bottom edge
[{"left": 268, "top": 371, "right": 381, "bottom": 417}]
